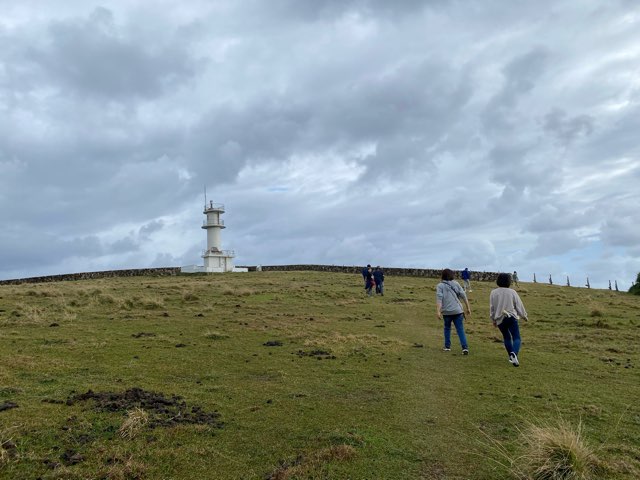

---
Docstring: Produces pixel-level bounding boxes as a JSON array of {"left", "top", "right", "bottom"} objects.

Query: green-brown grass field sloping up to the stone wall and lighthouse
[{"left": 0, "top": 272, "right": 640, "bottom": 479}]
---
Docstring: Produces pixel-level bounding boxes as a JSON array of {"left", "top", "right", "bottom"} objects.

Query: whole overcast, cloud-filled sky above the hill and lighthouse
[{"left": 0, "top": 0, "right": 640, "bottom": 289}]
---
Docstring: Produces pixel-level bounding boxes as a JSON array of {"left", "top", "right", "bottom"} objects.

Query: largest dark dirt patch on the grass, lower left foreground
[{"left": 66, "top": 387, "right": 224, "bottom": 428}]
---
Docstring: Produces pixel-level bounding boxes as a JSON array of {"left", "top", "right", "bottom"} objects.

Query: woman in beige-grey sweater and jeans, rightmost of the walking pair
[{"left": 489, "top": 273, "right": 528, "bottom": 367}]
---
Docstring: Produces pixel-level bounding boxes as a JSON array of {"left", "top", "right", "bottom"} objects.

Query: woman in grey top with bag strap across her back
[{"left": 436, "top": 268, "right": 471, "bottom": 355}]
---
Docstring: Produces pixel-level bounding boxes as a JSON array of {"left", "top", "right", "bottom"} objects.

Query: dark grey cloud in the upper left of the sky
[{"left": 23, "top": 7, "right": 195, "bottom": 101}]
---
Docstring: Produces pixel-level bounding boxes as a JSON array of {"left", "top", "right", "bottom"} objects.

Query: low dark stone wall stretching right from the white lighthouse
[{"left": 239, "top": 265, "right": 498, "bottom": 282}]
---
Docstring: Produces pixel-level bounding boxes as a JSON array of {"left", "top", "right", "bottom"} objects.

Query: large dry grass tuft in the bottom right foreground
[{"left": 513, "top": 420, "right": 602, "bottom": 480}]
